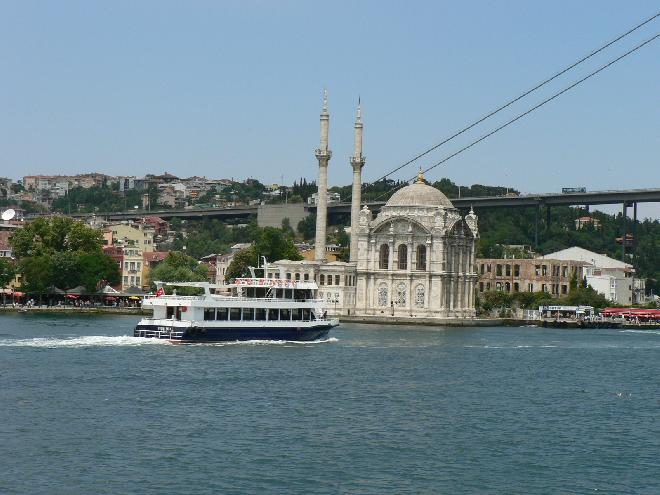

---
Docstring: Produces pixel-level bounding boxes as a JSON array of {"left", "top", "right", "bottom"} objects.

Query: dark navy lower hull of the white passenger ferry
[{"left": 133, "top": 324, "right": 334, "bottom": 343}]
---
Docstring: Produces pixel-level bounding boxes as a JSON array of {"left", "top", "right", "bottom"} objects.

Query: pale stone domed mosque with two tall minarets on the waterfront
[{"left": 267, "top": 93, "right": 478, "bottom": 318}]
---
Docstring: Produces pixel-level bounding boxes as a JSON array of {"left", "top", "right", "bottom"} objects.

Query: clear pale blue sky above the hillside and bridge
[{"left": 0, "top": 0, "right": 660, "bottom": 218}]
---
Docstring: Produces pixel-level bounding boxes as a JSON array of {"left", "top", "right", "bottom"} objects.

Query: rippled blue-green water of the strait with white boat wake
[{"left": 0, "top": 314, "right": 660, "bottom": 495}]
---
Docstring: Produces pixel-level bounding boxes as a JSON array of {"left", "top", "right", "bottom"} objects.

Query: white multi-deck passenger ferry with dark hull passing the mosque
[{"left": 133, "top": 277, "right": 339, "bottom": 342}]
